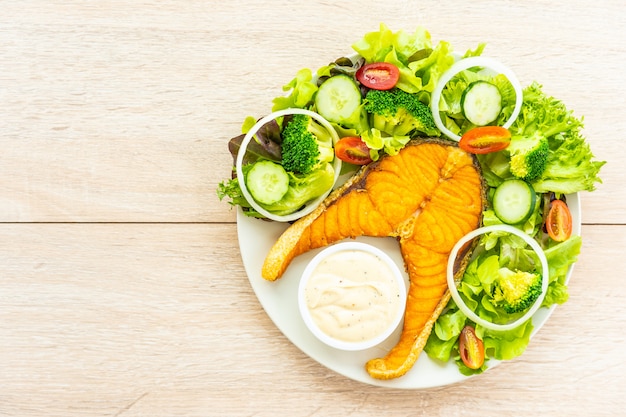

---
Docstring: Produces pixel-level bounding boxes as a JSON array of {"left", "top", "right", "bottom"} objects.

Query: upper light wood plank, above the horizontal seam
[{"left": 0, "top": 0, "right": 626, "bottom": 223}]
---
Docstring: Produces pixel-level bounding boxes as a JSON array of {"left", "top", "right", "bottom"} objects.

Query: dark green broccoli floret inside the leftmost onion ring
[{"left": 281, "top": 114, "right": 335, "bottom": 174}]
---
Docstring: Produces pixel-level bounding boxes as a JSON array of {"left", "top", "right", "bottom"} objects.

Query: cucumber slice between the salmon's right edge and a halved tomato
[{"left": 493, "top": 179, "right": 537, "bottom": 224}]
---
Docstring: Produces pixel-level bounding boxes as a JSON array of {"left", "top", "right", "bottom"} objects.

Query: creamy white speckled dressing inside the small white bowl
[{"left": 304, "top": 250, "right": 405, "bottom": 342}]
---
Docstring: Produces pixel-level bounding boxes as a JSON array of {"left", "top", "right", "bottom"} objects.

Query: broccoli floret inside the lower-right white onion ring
[{"left": 493, "top": 268, "right": 542, "bottom": 314}]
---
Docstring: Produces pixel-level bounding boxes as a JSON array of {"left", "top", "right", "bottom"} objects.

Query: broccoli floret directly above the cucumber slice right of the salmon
[{"left": 508, "top": 133, "right": 550, "bottom": 181}]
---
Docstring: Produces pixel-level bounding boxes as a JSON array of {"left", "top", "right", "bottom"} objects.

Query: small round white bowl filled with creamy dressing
[{"left": 298, "top": 241, "right": 407, "bottom": 351}]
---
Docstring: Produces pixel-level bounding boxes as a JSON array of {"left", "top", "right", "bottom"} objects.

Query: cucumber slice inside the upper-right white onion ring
[{"left": 461, "top": 81, "right": 502, "bottom": 126}]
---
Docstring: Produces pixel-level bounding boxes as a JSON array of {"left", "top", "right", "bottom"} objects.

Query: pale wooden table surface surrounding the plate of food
[{"left": 0, "top": 0, "right": 626, "bottom": 417}]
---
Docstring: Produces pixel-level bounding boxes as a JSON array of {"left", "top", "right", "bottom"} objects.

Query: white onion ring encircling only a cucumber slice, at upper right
[{"left": 430, "top": 56, "right": 524, "bottom": 142}]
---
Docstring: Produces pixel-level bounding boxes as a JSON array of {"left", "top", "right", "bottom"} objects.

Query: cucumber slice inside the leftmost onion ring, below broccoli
[{"left": 246, "top": 161, "right": 289, "bottom": 204}]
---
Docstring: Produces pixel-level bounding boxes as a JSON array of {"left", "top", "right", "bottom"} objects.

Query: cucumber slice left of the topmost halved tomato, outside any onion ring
[{"left": 315, "top": 74, "right": 362, "bottom": 124}]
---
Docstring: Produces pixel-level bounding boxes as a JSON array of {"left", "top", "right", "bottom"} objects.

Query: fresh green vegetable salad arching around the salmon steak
[{"left": 217, "top": 24, "right": 605, "bottom": 375}]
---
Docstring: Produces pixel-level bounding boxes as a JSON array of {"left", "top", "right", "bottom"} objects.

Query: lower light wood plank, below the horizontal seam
[{"left": 0, "top": 225, "right": 626, "bottom": 417}]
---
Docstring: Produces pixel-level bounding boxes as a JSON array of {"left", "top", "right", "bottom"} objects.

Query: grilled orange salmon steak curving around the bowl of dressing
[{"left": 262, "top": 139, "right": 485, "bottom": 379}]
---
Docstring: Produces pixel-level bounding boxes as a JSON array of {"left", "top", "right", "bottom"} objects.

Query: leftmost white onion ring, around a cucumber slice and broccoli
[{"left": 235, "top": 109, "right": 341, "bottom": 222}]
